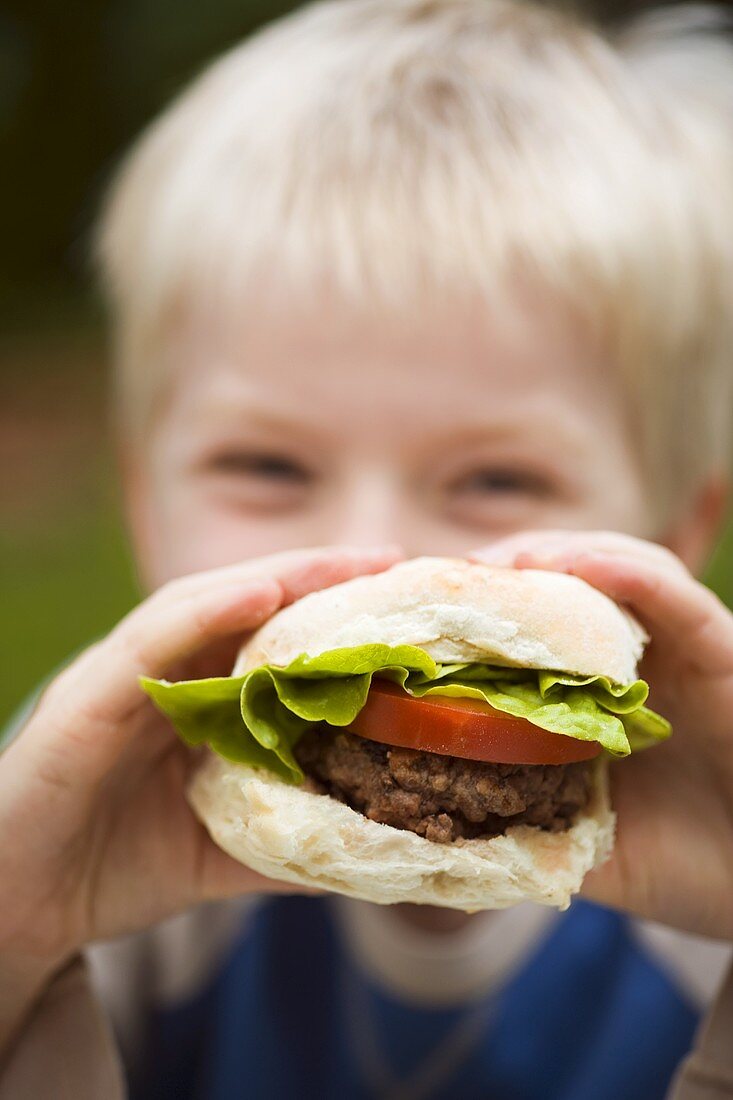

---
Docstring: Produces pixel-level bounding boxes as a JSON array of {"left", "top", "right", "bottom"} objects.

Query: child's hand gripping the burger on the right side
[{"left": 472, "top": 531, "right": 733, "bottom": 938}]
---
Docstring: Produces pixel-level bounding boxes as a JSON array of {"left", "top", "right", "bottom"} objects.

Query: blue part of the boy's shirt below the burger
[{"left": 131, "top": 898, "right": 698, "bottom": 1100}]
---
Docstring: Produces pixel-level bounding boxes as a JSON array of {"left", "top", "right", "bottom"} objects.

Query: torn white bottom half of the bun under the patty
[{"left": 188, "top": 756, "right": 615, "bottom": 912}]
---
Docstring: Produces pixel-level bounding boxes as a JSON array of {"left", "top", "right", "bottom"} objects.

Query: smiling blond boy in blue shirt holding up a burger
[{"left": 0, "top": 0, "right": 733, "bottom": 1100}]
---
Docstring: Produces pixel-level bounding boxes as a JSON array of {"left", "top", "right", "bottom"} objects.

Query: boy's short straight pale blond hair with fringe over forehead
[{"left": 99, "top": 0, "right": 733, "bottom": 514}]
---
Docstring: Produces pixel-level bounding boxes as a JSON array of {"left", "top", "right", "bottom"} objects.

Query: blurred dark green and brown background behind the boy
[{"left": 0, "top": 0, "right": 733, "bottom": 725}]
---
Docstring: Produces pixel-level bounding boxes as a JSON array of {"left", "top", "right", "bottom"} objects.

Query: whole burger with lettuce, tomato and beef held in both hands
[{"left": 142, "top": 558, "right": 670, "bottom": 911}]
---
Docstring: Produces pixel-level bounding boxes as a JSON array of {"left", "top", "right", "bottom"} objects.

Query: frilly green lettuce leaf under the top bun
[{"left": 141, "top": 645, "right": 671, "bottom": 783}]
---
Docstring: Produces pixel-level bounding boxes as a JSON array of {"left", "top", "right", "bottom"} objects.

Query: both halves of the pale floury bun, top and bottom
[{"left": 188, "top": 558, "right": 646, "bottom": 911}]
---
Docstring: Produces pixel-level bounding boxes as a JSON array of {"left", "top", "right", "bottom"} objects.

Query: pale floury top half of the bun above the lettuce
[{"left": 234, "top": 558, "right": 647, "bottom": 683}]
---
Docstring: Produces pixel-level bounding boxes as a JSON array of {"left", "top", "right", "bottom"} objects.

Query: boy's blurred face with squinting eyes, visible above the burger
[{"left": 131, "top": 290, "right": 653, "bottom": 585}]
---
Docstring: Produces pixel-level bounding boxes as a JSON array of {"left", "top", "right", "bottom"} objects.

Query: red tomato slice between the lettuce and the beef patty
[{"left": 349, "top": 680, "right": 601, "bottom": 763}]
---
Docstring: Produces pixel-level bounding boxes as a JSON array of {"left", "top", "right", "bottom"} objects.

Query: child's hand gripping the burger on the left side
[{"left": 0, "top": 548, "right": 396, "bottom": 1045}]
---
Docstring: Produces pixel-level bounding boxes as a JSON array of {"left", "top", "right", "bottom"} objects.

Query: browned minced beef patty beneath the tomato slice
[{"left": 295, "top": 726, "right": 592, "bottom": 844}]
